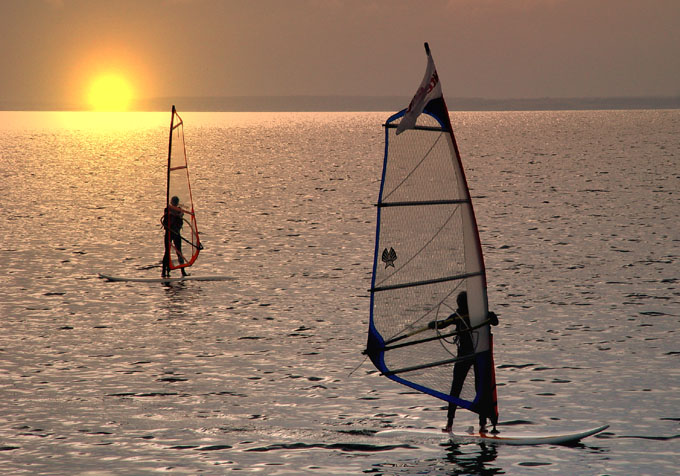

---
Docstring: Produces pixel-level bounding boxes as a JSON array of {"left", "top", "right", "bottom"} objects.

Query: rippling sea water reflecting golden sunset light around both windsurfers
[{"left": 0, "top": 110, "right": 680, "bottom": 475}]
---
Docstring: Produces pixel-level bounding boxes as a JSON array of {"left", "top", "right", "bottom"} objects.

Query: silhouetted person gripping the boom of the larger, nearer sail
[{"left": 428, "top": 291, "right": 498, "bottom": 433}]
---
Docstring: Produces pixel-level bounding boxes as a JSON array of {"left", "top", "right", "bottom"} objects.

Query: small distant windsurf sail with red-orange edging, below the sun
[{"left": 162, "top": 106, "right": 203, "bottom": 269}]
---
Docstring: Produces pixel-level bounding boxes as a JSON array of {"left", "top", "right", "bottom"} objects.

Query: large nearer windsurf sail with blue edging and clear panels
[{"left": 365, "top": 43, "right": 498, "bottom": 422}]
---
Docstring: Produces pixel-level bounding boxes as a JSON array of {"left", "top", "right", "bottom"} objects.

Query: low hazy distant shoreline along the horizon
[{"left": 0, "top": 96, "right": 680, "bottom": 112}]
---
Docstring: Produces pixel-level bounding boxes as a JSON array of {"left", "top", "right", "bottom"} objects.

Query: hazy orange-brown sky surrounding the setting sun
[{"left": 0, "top": 0, "right": 680, "bottom": 109}]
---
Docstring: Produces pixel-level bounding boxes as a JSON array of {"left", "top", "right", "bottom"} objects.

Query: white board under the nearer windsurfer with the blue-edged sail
[{"left": 375, "top": 425, "right": 609, "bottom": 445}]
